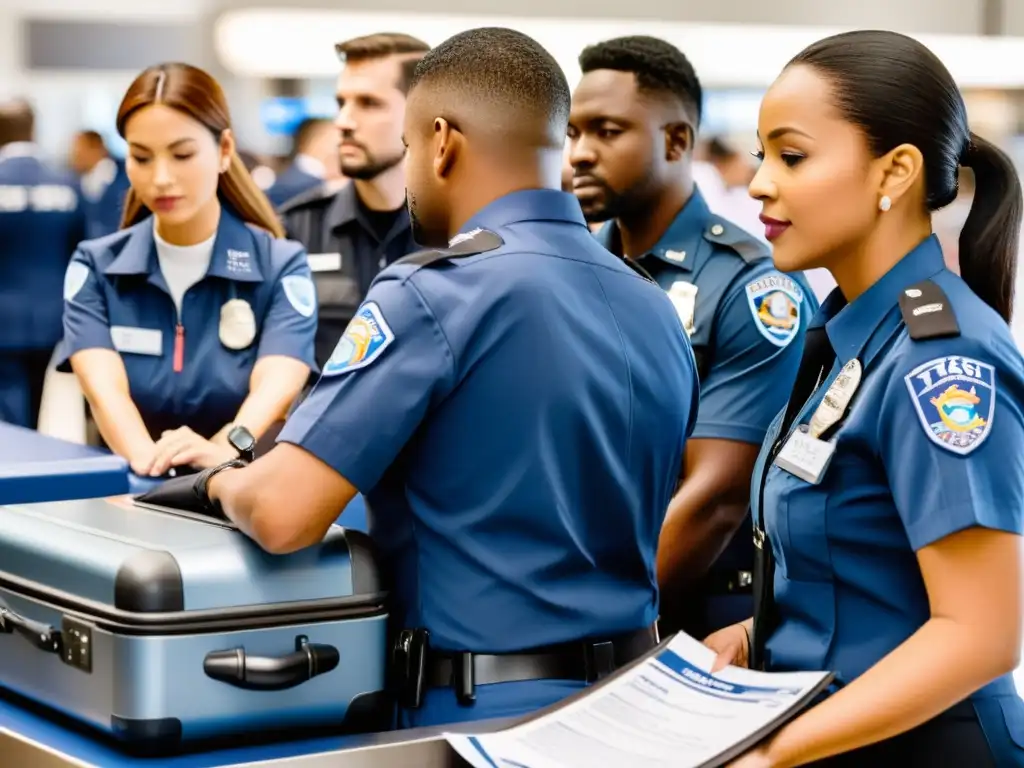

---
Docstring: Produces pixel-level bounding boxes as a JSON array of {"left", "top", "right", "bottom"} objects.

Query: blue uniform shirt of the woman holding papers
[{"left": 754, "top": 238, "right": 1024, "bottom": 749}]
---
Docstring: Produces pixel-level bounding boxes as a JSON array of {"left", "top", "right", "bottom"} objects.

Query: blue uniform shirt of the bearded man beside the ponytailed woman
[{"left": 597, "top": 189, "right": 817, "bottom": 444}]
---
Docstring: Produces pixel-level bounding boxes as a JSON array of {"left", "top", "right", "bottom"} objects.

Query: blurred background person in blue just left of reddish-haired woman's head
[{"left": 69, "top": 131, "right": 129, "bottom": 238}]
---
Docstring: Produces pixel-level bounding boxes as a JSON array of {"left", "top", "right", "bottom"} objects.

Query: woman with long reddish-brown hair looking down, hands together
[{"left": 61, "top": 63, "right": 316, "bottom": 476}]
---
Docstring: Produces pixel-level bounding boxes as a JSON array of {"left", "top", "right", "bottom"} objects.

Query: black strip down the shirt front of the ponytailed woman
[{"left": 748, "top": 327, "right": 836, "bottom": 670}]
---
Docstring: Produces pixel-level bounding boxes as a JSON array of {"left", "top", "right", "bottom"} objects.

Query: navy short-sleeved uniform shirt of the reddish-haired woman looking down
[{"left": 59, "top": 208, "right": 316, "bottom": 438}]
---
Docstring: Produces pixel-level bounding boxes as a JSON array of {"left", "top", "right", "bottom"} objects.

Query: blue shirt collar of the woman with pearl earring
[{"left": 810, "top": 234, "right": 945, "bottom": 366}]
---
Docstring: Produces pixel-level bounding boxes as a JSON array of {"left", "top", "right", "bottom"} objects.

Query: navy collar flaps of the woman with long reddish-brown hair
[{"left": 103, "top": 207, "right": 263, "bottom": 283}]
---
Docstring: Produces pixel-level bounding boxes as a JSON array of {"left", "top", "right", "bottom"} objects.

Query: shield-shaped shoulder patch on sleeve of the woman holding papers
[{"left": 903, "top": 355, "right": 995, "bottom": 456}]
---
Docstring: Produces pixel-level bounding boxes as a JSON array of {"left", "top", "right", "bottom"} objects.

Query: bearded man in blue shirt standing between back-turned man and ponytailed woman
[{"left": 569, "top": 37, "right": 816, "bottom": 637}]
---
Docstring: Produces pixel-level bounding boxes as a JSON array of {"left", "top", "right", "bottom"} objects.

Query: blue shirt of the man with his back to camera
[{"left": 280, "top": 190, "right": 697, "bottom": 651}]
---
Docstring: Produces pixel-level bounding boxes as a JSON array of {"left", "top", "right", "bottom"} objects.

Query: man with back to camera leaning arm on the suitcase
[{"left": 196, "top": 29, "right": 697, "bottom": 726}]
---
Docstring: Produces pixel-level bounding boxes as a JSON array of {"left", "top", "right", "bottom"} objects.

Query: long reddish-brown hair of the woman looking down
[{"left": 118, "top": 63, "right": 285, "bottom": 238}]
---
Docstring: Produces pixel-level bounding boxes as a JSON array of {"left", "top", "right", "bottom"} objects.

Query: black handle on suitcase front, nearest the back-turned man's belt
[{"left": 203, "top": 635, "right": 341, "bottom": 690}]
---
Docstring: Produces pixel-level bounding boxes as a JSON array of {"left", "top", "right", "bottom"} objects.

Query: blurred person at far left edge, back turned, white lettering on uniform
[{"left": 0, "top": 101, "right": 85, "bottom": 429}]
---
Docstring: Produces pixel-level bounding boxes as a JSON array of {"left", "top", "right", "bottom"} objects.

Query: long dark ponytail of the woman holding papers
[{"left": 959, "top": 133, "right": 1024, "bottom": 324}]
